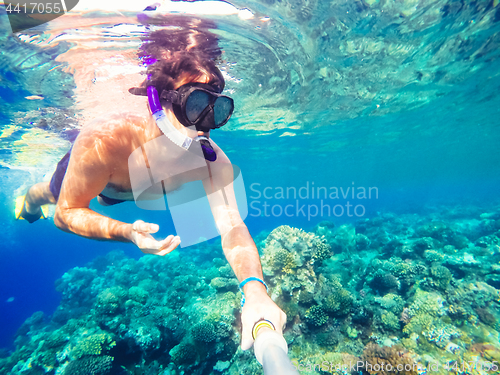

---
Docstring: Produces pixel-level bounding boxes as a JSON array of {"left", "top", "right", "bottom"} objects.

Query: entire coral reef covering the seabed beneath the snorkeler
[{"left": 0, "top": 209, "right": 500, "bottom": 375}]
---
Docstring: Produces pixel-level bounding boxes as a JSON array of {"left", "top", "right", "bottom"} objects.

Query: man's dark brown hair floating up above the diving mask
[{"left": 133, "top": 18, "right": 224, "bottom": 95}]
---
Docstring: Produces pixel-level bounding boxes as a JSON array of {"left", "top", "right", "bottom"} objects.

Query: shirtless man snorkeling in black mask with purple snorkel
[{"left": 13, "top": 30, "right": 286, "bottom": 350}]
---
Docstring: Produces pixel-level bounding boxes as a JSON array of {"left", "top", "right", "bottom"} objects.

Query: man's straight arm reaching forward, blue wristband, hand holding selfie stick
[{"left": 204, "top": 149, "right": 286, "bottom": 350}]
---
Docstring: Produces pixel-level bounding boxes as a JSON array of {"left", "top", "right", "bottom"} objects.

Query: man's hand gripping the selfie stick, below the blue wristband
[{"left": 241, "top": 281, "right": 286, "bottom": 350}]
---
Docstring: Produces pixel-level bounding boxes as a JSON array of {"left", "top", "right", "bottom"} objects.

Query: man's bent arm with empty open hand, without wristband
[{"left": 54, "top": 125, "right": 180, "bottom": 255}]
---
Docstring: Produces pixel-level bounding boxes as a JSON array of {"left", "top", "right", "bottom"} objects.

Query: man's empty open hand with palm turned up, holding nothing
[{"left": 129, "top": 220, "right": 181, "bottom": 256}]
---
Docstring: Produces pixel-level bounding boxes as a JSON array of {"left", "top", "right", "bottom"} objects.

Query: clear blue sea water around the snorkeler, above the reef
[{"left": 0, "top": 2, "right": 500, "bottom": 374}]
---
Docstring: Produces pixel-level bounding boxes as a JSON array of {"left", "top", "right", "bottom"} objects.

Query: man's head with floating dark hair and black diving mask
[{"left": 131, "top": 28, "right": 234, "bottom": 137}]
